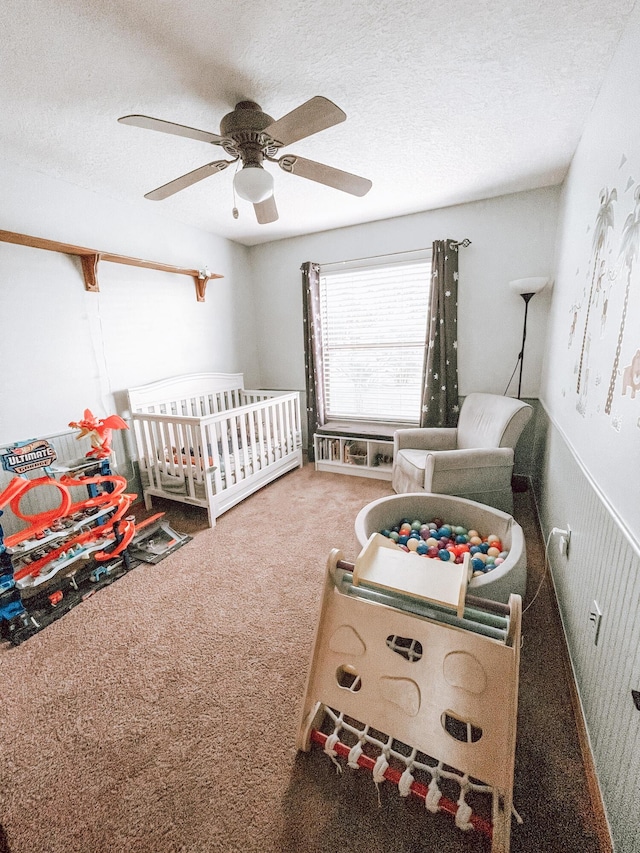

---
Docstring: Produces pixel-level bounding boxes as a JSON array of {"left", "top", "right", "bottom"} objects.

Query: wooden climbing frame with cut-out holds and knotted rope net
[{"left": 297, "top": 533, "right": 522, "bottom": 853}]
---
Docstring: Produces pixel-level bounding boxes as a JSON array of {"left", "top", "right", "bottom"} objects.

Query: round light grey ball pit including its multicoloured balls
[{"left": 355, "top": 492, "right": 526, "bottom": 603}]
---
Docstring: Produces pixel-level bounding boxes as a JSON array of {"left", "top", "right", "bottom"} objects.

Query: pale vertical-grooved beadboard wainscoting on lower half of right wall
[{"left": 532, "top": 406, "right": 640, "bottom": 853}]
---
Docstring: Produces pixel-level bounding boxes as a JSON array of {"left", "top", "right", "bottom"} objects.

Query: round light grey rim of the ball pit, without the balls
[{"left": 355, "top": 492, "right": 527, "bottom": 603}]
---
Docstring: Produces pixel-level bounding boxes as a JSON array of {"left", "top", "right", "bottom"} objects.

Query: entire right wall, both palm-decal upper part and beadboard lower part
[{"left": 535, "top": 6, "right": 640, "bottom": 853}]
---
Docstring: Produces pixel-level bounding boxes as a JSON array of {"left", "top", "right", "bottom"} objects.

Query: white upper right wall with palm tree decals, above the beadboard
[{"left": 542, "top": 1, "right": 640, "bottom": 541}]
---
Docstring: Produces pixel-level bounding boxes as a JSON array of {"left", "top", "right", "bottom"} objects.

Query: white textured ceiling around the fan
[{"left": 0, "top": 0, "right": 634, "bottom": 245}]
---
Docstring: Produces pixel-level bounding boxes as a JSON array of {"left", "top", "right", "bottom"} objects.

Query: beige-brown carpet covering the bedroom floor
[{"left": 0, "top": 465, "right": 601, "bottom": 853}]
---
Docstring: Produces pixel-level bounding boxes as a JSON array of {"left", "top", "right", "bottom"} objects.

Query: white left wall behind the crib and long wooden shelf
[{"left": 0, "top": 158, "right": 255, "bottom": 444}]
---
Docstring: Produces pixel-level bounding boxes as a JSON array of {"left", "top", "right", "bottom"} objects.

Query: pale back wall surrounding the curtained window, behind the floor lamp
[{"left": 251, "top": 187, "right": 559, "bottom": 397}]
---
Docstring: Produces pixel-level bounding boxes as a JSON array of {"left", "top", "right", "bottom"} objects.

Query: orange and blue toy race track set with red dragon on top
[{"left": 0, "top": 411, "right": 192, "bottom": 645}]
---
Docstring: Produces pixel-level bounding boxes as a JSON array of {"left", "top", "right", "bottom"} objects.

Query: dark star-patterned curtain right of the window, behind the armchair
[{"left": 420, "top": 240, "right": 459, "bottom": 427}]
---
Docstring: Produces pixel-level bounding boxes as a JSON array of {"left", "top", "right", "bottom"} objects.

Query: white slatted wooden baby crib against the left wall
[{"left": 128, "top": 373, "right": 302, "bottom": 527}]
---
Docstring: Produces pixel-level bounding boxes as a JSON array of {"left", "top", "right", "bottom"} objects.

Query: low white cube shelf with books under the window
[{"left": 313, "top": 433, "right": 393, "bottom": 480}]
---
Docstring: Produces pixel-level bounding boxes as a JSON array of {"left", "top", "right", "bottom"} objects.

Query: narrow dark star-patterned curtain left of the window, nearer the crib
[{"left": 300, "top": 261, "right": 325, "bottom": 462}]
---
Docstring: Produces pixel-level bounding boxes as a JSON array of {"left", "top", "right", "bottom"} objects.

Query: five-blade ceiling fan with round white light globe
[{"left": 118, "top": 95, "right": 372, "bottom": 225}]
